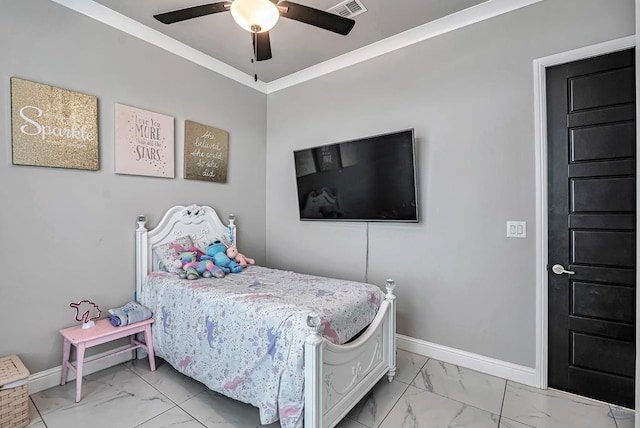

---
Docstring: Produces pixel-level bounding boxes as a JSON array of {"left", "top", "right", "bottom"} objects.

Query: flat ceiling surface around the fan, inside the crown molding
[{"left": 96, "top": 0, "right": 486, "bottom": 82}]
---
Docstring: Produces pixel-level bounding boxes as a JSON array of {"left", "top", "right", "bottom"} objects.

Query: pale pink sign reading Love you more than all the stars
[{"left": 115, "top": 104, "right": 175, "bottom": 178}]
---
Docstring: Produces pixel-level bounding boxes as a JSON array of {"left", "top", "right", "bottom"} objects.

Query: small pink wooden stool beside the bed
[{"left": 60, "top": 318, "right": 156, "bottom": 403}]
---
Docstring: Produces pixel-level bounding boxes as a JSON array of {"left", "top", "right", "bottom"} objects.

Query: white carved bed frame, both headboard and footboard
[{"left": 135, "top": 205, "right": 396, "bottom": 428}]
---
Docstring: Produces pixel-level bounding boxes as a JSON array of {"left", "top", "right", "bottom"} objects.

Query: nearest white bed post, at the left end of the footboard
[{"left": 304, "top": 312, "right": 323, "bottom": 428}]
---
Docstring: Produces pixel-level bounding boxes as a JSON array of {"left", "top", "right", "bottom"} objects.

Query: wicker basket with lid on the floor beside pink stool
[{"left": 0, "top": 355, "right": 29, "bottom": 428}]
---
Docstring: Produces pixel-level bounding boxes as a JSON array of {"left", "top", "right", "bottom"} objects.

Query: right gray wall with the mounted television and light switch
[{"left": 267, "top": 0, "right": 635, "bottom": 367}]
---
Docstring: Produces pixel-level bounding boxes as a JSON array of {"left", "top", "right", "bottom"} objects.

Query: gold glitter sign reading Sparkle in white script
[{"left": 11, "top": 77, "right": 99, "bottom": 171}]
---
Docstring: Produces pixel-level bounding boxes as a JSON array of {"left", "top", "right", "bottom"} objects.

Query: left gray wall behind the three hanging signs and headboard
[{"left": 0, "top": 0, "right": 266, "bottom": 373}]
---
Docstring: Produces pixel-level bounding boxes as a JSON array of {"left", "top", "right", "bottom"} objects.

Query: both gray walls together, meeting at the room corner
[{"left": 0, "top": 0, "right": 634, "bottom": 373}]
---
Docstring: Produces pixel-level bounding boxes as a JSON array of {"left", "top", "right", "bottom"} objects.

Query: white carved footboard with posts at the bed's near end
[{"left": 304, "top": 280, "right": 396, "bottom": 428}]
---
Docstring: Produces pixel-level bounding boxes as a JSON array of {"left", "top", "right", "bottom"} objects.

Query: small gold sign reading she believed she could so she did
[{"left": 184, "top": 120, "right": 229, "bottom": 183}]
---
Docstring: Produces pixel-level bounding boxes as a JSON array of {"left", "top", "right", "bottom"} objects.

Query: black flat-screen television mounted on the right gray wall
[{"left": 294, "top": 129, "right": 418, "bottom": 222}]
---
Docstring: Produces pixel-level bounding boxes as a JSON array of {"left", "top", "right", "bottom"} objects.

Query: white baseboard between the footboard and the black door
[{"left": 396, "top": 334, "right": 540, "bottom": 388}]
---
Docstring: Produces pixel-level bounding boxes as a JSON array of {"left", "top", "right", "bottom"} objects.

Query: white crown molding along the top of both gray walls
[{"left": 51, "top": 0, "right": 543, "bottom": 94}]
